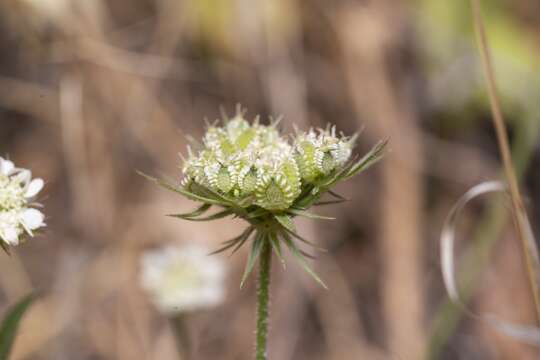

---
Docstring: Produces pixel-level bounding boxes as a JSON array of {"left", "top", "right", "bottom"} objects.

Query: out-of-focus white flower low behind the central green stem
[{"left": 141, "top": 245, "right": 225, "bottom": 314}]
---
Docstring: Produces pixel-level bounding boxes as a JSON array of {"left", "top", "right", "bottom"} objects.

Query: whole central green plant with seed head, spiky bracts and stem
[{"left": 143, "top": 110, "right": 386, "bottom": 360}]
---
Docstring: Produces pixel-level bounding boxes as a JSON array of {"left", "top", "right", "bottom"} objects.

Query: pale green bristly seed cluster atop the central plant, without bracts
[{"left": 182, "top": 114, "right": 354, "bottom": 210}]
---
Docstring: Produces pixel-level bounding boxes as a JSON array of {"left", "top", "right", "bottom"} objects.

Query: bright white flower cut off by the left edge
[{"left": 0, "top": 157, "right": 45, "bottom": 245}]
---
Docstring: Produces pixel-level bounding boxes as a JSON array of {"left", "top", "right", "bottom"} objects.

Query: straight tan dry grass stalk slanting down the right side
[{"left": 471, "top": 0, "right": 540, "bottom": 322}]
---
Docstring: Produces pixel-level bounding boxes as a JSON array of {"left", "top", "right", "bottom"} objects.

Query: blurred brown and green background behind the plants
[{"left": 0, "top": 0, "right": 540, "bottom": 360}]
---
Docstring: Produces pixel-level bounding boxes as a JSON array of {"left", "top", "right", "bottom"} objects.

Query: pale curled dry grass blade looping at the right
[{"left": 440, "top": 181, "right": 540, "bottom": 346}]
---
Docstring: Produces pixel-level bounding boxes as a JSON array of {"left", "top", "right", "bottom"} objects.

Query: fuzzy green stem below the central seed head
[{"left": 255, "top": 237, "right": 272, "bottom": 360}]
